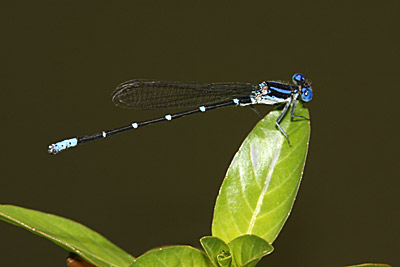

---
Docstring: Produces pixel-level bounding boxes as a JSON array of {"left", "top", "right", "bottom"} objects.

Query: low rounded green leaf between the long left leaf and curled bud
[{"left": 131, "top": 246, "right": 213, "bottom": 267}]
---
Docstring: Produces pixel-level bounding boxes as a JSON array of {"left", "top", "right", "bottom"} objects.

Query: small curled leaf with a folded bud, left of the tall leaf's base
[{"left": 200, "top": 236, "right": 232, "bottom": 267}]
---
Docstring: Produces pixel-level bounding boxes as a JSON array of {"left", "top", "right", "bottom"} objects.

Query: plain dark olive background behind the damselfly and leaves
[{"left": 0, "top": 0, "right": 400, "bottom": 266}]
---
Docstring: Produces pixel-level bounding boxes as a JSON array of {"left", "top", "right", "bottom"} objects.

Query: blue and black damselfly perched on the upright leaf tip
[{"left": 48, "top": 73, "right": 313, "bottom": 154}]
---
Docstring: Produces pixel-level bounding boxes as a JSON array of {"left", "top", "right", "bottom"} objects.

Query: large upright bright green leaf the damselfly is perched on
[{"left": 212, "top": 103, "right": 310, "bottom": 243}]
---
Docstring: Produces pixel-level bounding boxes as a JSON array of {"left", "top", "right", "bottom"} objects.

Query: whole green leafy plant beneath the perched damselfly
[{"left": 0, "top": 103, "right": 388, "bottom": 267}]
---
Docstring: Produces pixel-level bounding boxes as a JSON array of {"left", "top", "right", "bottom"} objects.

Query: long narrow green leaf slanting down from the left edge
[{"left": 0, "top": 205, "right": 134, "bottom": 267}]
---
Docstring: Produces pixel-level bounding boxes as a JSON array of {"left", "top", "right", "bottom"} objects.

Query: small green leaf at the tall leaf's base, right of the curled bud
[{"left": 229, "top": 235, "right": 274, "bottom": 267}]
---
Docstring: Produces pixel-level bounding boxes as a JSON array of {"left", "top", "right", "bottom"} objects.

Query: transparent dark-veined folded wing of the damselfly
[{"left": 112, "top": 80, "right": 257, "bottom": 109}]
